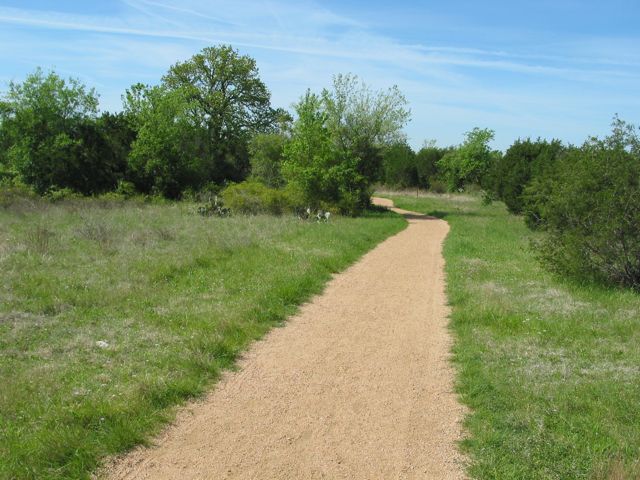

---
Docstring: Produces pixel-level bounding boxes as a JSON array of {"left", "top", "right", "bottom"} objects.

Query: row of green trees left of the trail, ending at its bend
[{"left": 0, "top": 45, "right": 409, "bottom": 214}]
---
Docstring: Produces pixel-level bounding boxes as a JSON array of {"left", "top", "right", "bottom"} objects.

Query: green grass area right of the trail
[{"left": 384, "top": 192, "right": 640, "bottom": 480}]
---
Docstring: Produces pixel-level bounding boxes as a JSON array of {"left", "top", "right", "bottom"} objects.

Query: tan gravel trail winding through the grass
[{"left": 108, "top": 199, "right": 465, "bottom": 480}]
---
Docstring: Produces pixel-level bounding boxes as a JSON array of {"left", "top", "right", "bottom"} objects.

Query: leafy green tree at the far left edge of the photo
[{"left": 1, "top": 69, "right": 119, "bottom": 194}]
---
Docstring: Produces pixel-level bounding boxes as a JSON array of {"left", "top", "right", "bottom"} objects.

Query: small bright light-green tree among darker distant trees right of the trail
[{"left": 437, "top": 127, "right": 496, "bottom": 192}]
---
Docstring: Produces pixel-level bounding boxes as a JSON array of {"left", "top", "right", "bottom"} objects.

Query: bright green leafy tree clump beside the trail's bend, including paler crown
[{"left": 282, "top": 75, "right": 409, "bottom": 215}]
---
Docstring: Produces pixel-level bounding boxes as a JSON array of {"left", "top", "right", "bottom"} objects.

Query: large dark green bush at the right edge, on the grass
[{"left": 528, "top": 118, "right": 640, "bottom": 289}]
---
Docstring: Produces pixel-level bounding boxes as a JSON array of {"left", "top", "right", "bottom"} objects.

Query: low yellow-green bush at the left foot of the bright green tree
[{"left": 222, "top": 181, "right": 302, "bottom": 215}]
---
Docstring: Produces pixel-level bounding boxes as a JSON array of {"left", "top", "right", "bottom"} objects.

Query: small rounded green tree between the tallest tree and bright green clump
[{"left": 249, "top": 133, "right": 287, "bottom": 188}]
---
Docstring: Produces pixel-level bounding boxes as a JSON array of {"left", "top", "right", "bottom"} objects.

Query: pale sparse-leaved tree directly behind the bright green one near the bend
[{"left": 321, "top": 75, "right": 410, "bottom": 182}]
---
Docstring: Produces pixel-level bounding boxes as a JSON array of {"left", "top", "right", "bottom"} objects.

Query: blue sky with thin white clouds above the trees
[{"left": 0, "top": 0, "right": 640, "bottom": 149}]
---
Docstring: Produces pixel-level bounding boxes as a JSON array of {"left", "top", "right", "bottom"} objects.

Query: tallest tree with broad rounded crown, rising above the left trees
[{"left": 163, "top": 45, "right": 275, "bottom": 181}]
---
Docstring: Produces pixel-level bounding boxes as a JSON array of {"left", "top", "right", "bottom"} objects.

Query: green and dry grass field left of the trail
[{"left": 0, "top": 200, "right": 405, "bottom": 479}]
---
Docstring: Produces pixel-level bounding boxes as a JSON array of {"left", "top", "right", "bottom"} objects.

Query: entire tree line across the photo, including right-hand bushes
[{"left": 0, "top": 45, "right": 640, "bottom": 289}]
